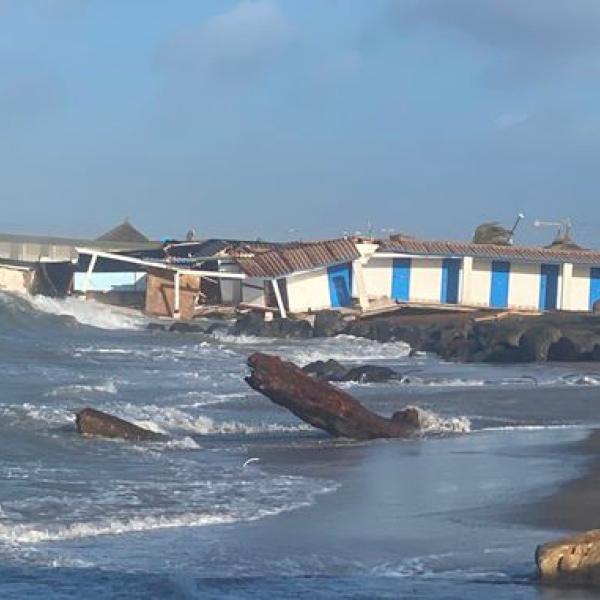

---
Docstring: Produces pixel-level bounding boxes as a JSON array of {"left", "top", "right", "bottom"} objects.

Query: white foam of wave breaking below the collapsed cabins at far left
[{"left": 28, "top": 296, "right": 146, "bottom": 329}]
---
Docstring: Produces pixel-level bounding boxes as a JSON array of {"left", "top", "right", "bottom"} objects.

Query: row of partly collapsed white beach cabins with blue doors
[{"left": 0, "top": 222, "right": 600, "bottom": 319}]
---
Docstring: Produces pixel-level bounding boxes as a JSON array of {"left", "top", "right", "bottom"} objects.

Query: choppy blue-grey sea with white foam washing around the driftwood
[{"left": 0, "top": 293, "right": 600, "bottom": 600}]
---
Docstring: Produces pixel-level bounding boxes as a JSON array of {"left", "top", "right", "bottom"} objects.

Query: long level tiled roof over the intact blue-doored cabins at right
[{"left": 377, "top": 238, "right": 600, "bottom": 265}]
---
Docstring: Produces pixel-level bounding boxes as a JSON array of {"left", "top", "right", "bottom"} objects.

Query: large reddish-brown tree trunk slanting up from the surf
[{"left": 246, "top": 352, "right": 420, "bottom": 440}]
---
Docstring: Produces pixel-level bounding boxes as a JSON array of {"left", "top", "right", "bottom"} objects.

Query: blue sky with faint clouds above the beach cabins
[{"left": 0, "top": 0, "right": 600, "bottom": 247}]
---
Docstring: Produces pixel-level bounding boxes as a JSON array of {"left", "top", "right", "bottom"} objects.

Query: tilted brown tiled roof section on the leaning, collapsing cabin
[{"left": 235, "top": 240, "right": 360, "bottom": 278}]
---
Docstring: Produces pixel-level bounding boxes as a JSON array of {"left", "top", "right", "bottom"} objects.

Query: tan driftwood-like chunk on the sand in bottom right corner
[{"left": 535, "top": 529, "right": 600, "bottom": 586}]
